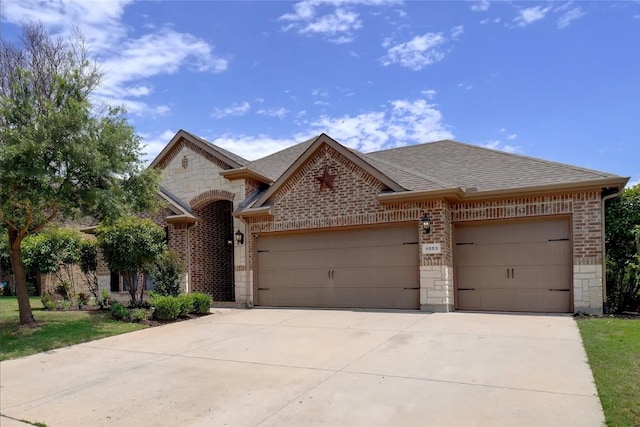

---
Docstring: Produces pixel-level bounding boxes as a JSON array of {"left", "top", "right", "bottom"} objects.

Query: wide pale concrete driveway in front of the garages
[{"left": 0, "top": 309, "right": 604, "bottom": 427}]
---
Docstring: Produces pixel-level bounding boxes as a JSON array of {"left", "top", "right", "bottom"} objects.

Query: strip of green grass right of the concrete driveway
[{"left": 577, "top": 317, "right": 640, "bottom": 427}]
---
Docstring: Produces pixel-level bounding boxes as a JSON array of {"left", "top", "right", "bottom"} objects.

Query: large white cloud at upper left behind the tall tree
[{"left": 2, "top": 0, "right": 228, "bottom": 115}]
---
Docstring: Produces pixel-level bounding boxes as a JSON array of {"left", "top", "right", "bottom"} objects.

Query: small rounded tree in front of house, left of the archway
[{"left": 96, "top": 217, "right": 165, "bottom": 307}]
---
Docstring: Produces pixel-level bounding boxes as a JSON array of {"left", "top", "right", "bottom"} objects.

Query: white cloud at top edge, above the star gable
[{"left": 279, "top": 0, "right": 401, "bottom": 44}]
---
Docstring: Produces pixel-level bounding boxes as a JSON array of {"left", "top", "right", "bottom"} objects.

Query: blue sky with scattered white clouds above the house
[{"left": 0, "top": 0, "right": 640, "bottom": 187}]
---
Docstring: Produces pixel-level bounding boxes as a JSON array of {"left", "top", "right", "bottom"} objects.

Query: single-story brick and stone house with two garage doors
[{"left": 102, "top": 130, "right": 628, "bottom": 313}]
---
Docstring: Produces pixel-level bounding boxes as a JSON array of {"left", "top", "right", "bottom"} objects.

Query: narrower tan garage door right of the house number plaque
[{"left": 454, "top": 219, "right": 571, "bottom": 313}]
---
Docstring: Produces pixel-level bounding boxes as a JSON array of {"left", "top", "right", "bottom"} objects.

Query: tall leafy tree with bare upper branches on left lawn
[{"left": 0, "top": 24, "right": 158, "bottom": 324}]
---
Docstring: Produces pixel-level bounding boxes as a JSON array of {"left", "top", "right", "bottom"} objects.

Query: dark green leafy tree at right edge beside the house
[{"left": 605, "top": 184, "right": 640, "bottom": 312}]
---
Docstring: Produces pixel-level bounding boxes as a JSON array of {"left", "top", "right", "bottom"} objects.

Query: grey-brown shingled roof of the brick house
[{"left": 170, "top": 131, "right": 628, "bottom": 204}]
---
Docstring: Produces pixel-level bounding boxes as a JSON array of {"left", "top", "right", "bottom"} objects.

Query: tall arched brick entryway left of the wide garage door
[{"left": 191, "top": 200, "right": 234, "bottom": 301}]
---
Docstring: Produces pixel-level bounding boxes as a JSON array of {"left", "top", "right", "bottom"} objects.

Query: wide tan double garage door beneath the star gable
[{"left": 256, "top": 224, "right": 420, "bottom": 309}]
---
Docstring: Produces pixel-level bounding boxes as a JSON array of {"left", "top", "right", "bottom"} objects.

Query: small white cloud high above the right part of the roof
[{"left": 382, "top": 33, "right": 447, "bottom": 71}]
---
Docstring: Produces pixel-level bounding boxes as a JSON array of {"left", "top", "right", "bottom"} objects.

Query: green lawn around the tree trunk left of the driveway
[{"left": 0, "top": 297, "right": 147, "bottom": 360}]
